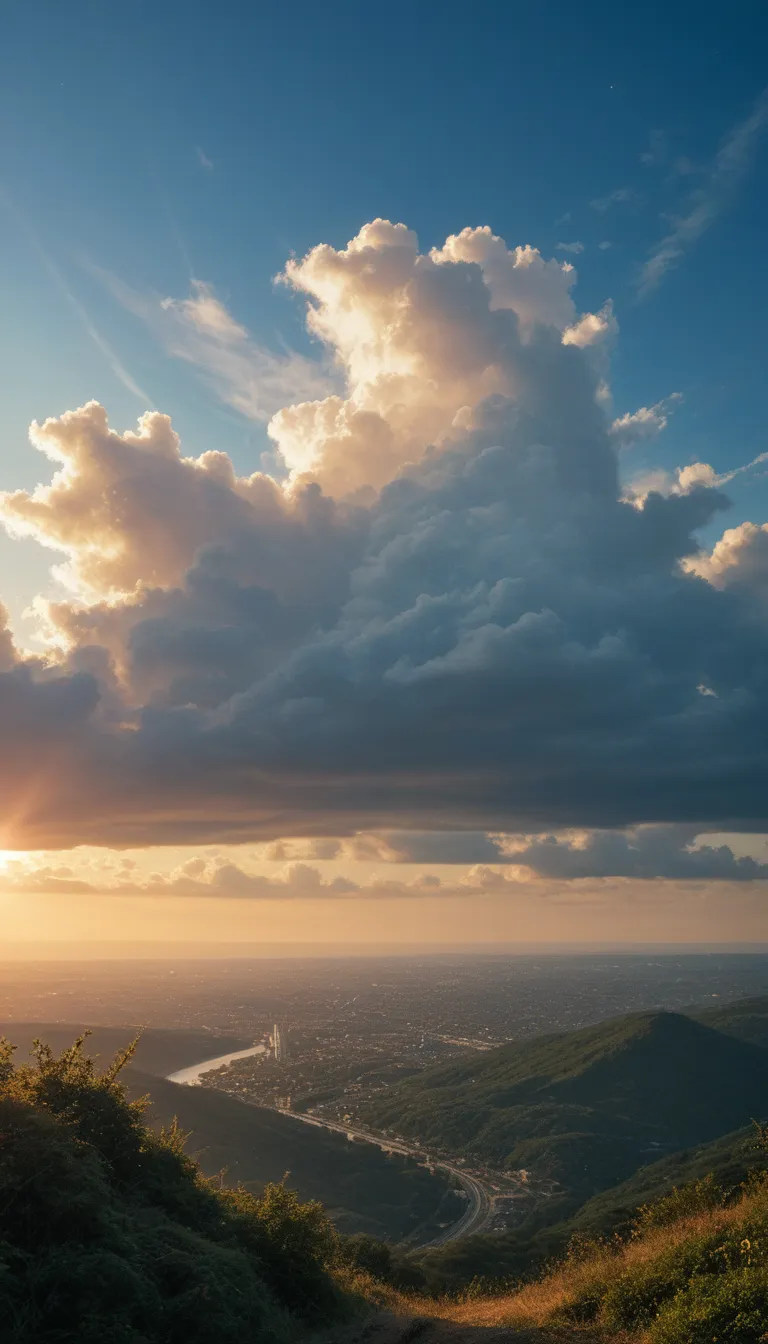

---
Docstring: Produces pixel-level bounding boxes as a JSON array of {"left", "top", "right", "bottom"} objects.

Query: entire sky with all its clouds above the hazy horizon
[{"left": 0, "top": 0, "right": 768, "bottom": 948}]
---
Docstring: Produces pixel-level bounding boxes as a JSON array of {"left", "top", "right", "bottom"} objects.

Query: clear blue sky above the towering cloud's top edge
[{"left": 0, "top": 0, "right": 768, "bottom": 485}]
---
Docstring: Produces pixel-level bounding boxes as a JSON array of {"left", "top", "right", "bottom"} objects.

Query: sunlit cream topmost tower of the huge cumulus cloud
[{"left": 269, "top": 219, "right": 576, "bottom": 497}]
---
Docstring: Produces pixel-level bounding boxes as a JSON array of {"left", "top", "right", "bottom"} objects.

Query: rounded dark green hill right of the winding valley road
[{"left": 364, "top": 1012, "right": 768, "bottom": 1208}]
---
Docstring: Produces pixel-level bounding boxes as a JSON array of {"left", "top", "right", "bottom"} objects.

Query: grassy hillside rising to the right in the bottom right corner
[{"left": 401, "top": 1179, "right": 768, "bottom": 1344}]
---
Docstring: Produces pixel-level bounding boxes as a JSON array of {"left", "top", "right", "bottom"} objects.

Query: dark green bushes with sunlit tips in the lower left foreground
[{"left": 0, "top": 1038, "right": 343, "bottom": 1344}]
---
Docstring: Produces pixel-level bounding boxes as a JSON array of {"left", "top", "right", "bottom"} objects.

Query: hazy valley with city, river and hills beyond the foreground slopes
[{"left": 6, "top": 957, "right": 768, "bottom": 1286}]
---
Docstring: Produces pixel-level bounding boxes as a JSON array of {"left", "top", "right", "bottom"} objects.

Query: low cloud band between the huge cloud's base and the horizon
[{"left": 7, "top": 824, "right": 768, "bottom": 900}]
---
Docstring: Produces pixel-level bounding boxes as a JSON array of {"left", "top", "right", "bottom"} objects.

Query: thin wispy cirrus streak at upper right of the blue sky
[{"left": 638, "top": 89, "right": 768, "bottom": 298}]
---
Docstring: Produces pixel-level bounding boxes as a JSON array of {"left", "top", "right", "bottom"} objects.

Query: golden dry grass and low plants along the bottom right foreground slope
[{"left": 334, "top": 1176, "right": 768, "bottom": 1344}]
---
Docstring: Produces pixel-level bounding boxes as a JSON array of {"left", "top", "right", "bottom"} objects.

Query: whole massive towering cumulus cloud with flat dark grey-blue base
[{"left": 0, "top": 220, "right": 768, "bottom": 849}]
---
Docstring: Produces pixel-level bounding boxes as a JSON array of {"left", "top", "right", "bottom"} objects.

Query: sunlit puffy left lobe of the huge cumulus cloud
[{"left": 0, "top": 402, "right": 363, "bottom": 610}]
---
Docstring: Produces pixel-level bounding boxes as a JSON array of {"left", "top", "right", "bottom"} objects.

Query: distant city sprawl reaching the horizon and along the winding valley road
[{"left": 0, "top": 953, "right": 768, "bottom": 1231}]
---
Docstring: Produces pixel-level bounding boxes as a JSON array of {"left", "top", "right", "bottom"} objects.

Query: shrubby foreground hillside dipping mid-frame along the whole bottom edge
[{"left": 0, "top": 1024, "right": 768, "bottom": 1344}]
